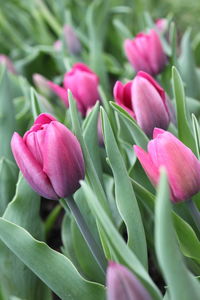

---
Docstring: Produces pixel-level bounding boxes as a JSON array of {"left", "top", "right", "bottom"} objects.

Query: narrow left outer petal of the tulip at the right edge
[{"left": 133, "top": 145, "right": 159, "bottom": 185}]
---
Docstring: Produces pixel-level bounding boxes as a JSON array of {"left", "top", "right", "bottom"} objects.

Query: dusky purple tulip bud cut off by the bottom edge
[{"left": 106, "top": 262, "right": 151, "bottom": 300}]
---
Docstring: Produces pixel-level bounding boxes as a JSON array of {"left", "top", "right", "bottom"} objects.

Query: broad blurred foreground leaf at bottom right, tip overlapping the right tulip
[{"left": 155, "top": 170, "right": 200, "bottom": 300}]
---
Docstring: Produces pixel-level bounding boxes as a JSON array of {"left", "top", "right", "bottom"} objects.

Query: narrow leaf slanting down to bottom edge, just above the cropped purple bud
[{"left": 81, "top": 182, "right": 161, "bottom": 300}]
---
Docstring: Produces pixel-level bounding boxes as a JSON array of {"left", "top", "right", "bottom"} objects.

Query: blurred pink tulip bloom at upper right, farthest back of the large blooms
[{"left": 124, "top": 29, "right": 167, "bottom": 75}]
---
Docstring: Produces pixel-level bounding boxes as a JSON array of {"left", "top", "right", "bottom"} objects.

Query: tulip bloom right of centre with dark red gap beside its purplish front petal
[{"left": 113, "top": 71, "right": 175, "bottom": 137}]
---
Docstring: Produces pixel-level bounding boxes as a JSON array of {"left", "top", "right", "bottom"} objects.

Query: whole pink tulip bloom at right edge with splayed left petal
[{"left": 134, "top": 128, "right": 200, "bottom": 202}]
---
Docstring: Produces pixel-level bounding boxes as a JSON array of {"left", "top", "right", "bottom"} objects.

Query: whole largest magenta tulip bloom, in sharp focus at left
[{"left": 11, "top": 114, "right": 85, "bottom": 199}]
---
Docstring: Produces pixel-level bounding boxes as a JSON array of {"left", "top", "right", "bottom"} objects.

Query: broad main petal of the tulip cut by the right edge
[{"left": 148, "top": 132, "right": 200, "bottom": 202}]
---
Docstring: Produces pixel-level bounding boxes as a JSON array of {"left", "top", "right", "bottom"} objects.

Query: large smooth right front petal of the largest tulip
[{"left": 43, "top": 121, "right": 84, "bottom": 197}]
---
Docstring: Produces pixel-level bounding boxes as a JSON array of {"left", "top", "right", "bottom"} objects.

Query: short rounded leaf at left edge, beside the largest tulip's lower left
[{"left": 0, "top": 157, "right": 18, "bottom": 216}]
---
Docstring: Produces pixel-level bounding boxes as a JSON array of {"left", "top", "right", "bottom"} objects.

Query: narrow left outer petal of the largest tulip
[{"left": 11, "top": 133, "right": 58, "bottom": 200}]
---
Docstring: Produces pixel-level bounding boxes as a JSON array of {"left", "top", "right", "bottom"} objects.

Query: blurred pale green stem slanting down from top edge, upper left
[{"left": 37, "top": 0, "right": 62, "bottom": 36}]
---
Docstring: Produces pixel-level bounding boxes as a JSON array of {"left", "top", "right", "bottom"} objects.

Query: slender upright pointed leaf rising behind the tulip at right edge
[{"left": 172, "top": 67, "right": 196, "bottom": 153}]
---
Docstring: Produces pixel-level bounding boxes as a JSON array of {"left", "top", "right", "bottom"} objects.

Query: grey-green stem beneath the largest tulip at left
[{"left": 60, "top": 196, "right": 107, "bottom": 274}]
